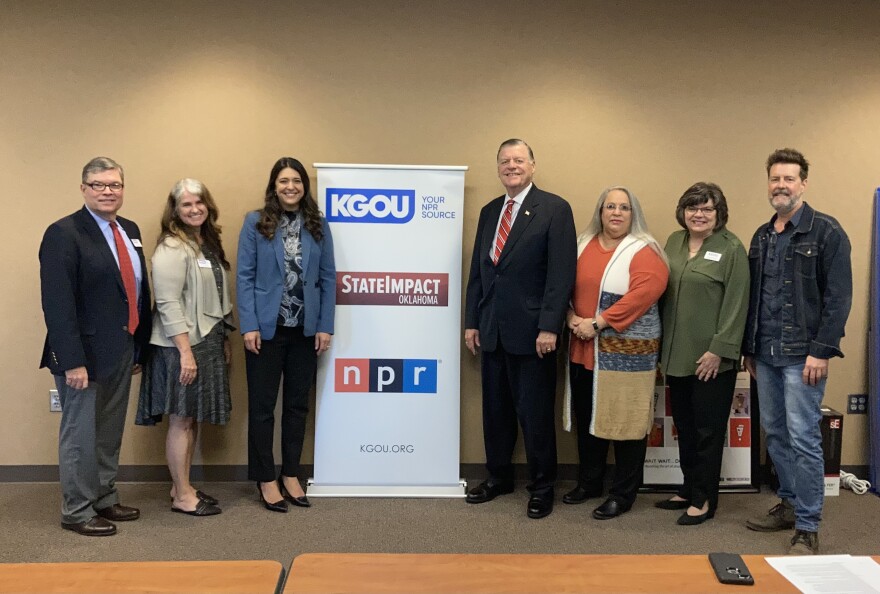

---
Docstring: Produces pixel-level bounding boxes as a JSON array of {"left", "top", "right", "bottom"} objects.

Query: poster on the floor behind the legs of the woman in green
[{"left": 643, "top": 372, "right": 760, "bottom": 491}]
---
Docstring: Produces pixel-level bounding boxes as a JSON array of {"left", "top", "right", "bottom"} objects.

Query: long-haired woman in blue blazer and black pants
[{"left": 237, "top": 157, "right": 336, "bottom": 512}]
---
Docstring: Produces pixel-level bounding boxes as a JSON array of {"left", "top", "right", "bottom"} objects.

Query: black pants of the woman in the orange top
[{"left": 569, "top": 363, "right": 648, "bottom": 508}]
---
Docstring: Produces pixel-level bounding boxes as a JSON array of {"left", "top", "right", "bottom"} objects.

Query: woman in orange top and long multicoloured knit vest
[{"left": 562, "top": 186, "right": 669, "bottom": 520}]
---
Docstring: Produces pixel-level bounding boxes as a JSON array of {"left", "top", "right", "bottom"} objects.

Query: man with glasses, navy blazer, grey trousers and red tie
[{"left": 40, "top": 157, "right": 151, "bottom": 536}]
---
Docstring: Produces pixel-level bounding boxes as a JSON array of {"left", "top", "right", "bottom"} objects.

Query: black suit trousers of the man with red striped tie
[{"left": 481, "top": 341, "right": 556, "bottom": 497}]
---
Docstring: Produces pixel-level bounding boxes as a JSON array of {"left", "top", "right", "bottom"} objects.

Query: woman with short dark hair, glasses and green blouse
[{"left": 656, "top": 182, "right": 749, "bottom": 526}]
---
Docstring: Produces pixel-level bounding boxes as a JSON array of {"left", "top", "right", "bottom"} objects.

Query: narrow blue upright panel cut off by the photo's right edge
[{"left": 868, "top": 188, "right": 880, "bottom": 495}]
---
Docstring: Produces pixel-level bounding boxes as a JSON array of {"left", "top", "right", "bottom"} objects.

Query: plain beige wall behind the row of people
[{"left": 0, "top": 0, "right": 880, "bottom": 465}]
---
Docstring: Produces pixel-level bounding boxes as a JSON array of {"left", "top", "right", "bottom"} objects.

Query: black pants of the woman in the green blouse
[{"left": 666, "top": 369, "right": 736, "bottom": 512}]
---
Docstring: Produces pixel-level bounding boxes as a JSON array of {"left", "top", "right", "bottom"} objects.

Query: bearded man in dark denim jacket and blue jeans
[{"left": 742, "top": 149, "right": 852, "bottom": 555}]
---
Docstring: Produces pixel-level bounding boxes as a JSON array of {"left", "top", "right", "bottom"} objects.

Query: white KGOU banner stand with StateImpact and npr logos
[{"left": 308, "top": 163, "right": 467, "bottom": 497}]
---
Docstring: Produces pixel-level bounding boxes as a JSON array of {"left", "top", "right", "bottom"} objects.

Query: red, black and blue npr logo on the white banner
[{"left": 335, "top": 359, "right": 437, "bottom": 394}]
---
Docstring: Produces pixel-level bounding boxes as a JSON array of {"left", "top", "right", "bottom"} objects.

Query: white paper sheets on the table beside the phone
[{"left": 765, "top": 555, "right": 880, "bottom": 594}]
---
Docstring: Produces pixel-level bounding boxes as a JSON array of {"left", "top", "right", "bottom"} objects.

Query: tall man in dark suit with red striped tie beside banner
[{"left": 464, "top": 138, "right": 577, "bottom": 518}]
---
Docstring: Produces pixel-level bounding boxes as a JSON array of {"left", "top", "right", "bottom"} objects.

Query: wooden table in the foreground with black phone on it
[{"left": 284, "top": 554, "right": 880, "bottom": 594}]
